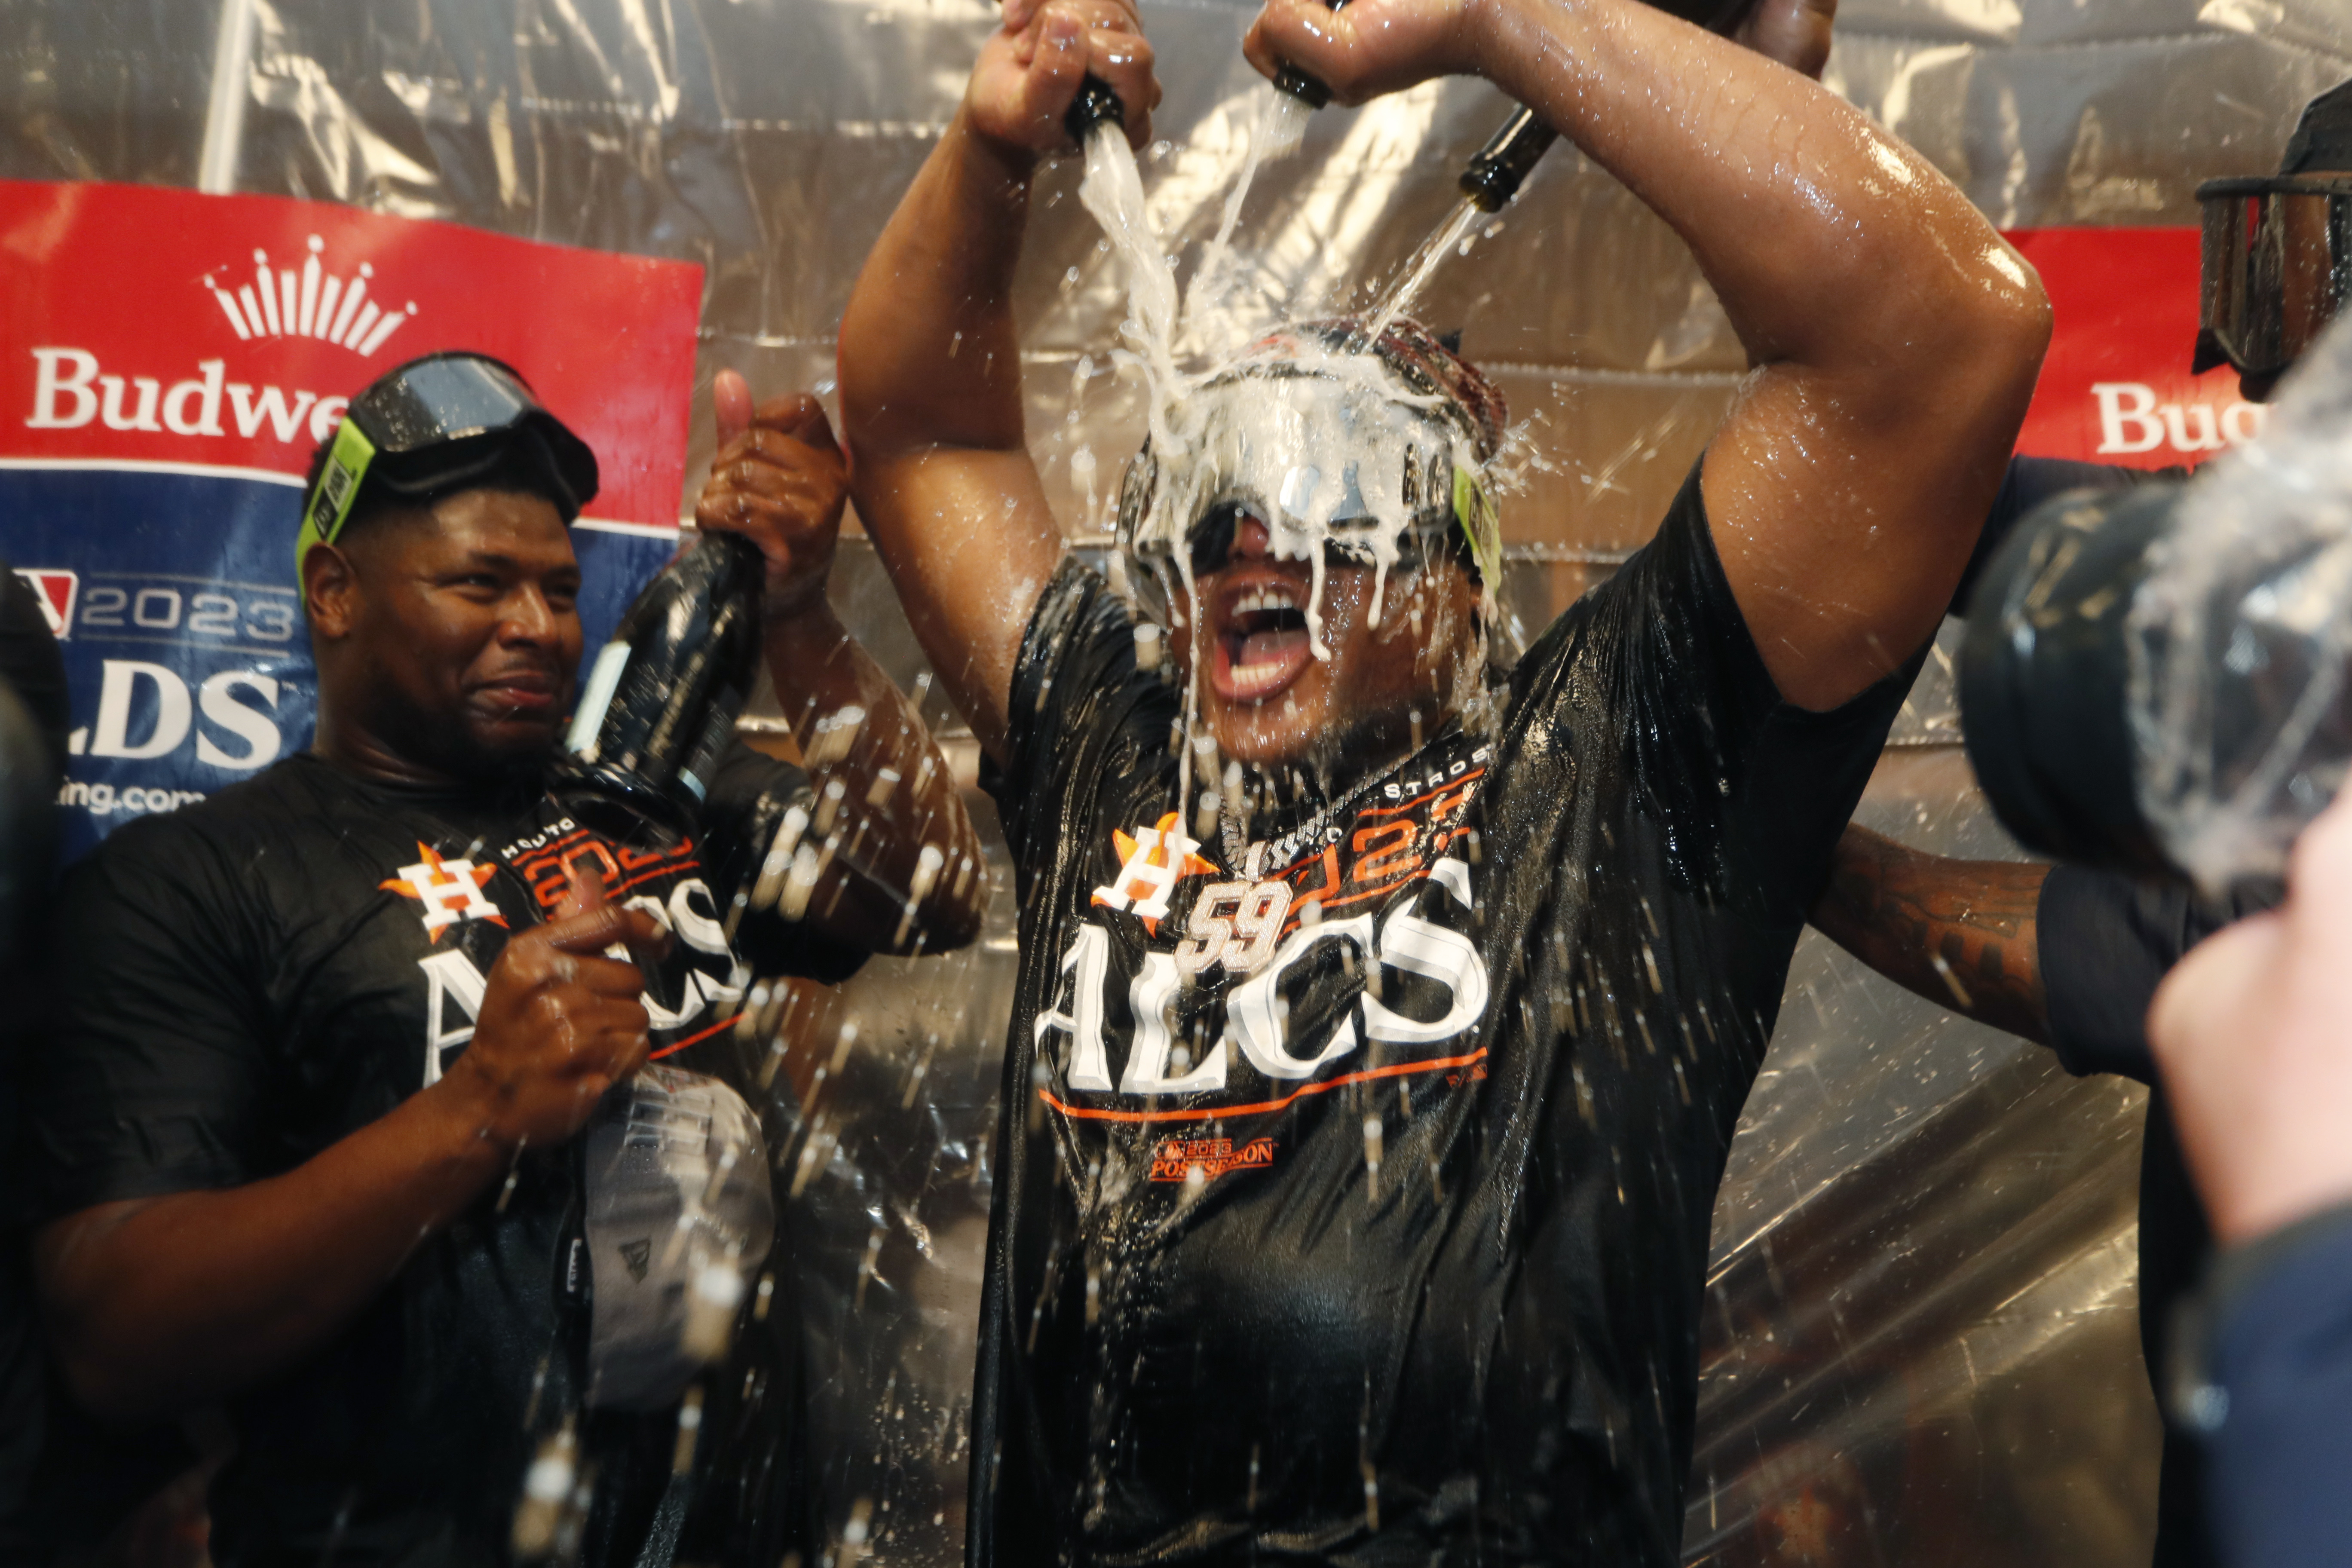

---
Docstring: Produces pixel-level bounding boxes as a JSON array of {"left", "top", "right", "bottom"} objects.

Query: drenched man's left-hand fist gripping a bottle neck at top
[{"left": 965, "top": 0, "right": 1160, "bottom": 153}]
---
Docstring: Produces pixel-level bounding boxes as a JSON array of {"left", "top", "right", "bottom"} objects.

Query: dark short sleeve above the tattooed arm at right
[{"left": 2034, "top": 865, "right": 2272, "bottom": 1084}]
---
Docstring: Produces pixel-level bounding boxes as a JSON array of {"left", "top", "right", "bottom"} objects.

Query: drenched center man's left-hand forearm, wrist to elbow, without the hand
[{"left": 840, "top": 108, "right": 1035, "bottom": 468}]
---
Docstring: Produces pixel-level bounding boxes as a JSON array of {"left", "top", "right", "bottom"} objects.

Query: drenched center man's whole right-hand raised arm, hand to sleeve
[{"left": 1246, "top": 0, "right": 2049, "bottom": 707}]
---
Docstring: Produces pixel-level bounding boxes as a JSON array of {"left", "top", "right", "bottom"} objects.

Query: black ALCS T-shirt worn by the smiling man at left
[{"left": 26, "top": 750, "right": 854, "bottom": 1568}]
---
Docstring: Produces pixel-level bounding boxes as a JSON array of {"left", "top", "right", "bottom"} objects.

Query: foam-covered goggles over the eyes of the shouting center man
[{"left": 1120, "top": 369, "right": 1503, "bottom": 621}]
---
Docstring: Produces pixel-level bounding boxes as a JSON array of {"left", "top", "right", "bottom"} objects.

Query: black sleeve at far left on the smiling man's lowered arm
[{"left": 24, "top": 818, "right": 278, "bottom": 1222}]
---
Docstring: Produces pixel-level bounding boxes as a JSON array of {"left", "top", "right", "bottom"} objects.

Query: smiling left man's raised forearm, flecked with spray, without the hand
[{"left": 767, "top": 600, "right": 988, "bottom": 952}]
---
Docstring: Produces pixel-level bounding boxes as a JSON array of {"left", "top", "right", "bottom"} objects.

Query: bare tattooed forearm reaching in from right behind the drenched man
[{"left": 1811, "top": 827, "right": 2049, "bottom": 1044}]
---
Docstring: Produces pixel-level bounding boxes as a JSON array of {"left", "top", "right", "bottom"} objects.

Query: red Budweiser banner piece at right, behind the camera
[{"left": 2009, "top": 228, "right": 2263, "bottom": 468}]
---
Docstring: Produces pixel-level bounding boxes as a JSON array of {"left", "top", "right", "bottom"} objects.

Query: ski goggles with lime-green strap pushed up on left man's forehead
[{"left": 294, "top": 352, "right": 597, "bottom": 576}]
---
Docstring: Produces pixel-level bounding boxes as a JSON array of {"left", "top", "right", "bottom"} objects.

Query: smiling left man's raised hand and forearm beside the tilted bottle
[{"left": 694, "top": 371, "right": 988, "bottom": 952}]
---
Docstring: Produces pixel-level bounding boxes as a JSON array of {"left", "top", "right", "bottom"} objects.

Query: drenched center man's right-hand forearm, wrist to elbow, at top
[{"left": 1465, "top": 0, "right": 2030, "bottom": 374}]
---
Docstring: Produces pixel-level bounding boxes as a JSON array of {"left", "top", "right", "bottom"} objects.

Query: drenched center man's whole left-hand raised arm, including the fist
[{"left": 842, "top": 0, "right": 1160, "bottom": 760}]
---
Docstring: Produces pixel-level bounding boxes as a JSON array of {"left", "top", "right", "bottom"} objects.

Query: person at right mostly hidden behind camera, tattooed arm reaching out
[{"left": 1811, "top": 82, "right": 2352, "bottom": 1568}]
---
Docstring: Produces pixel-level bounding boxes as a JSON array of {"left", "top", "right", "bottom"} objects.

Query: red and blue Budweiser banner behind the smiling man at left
[{"left": 0, "top": 181, "right": 701, "bottom": 856}]
